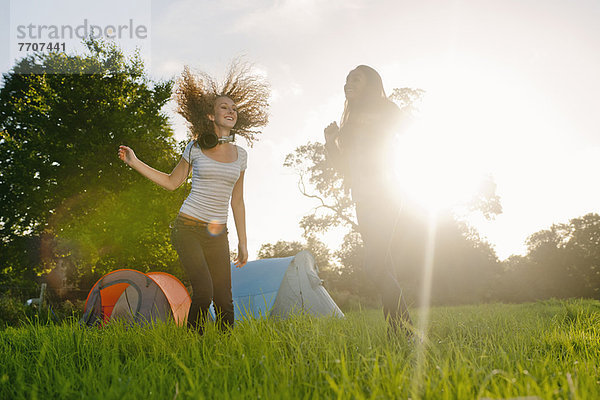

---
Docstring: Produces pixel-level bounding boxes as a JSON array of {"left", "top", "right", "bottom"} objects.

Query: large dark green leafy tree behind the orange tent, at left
[{"left": 0, "top": 40, "right": 182, "bottom": 290}]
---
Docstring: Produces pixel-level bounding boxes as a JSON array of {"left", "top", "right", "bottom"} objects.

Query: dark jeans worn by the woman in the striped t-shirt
[{"left": 171, "top": 216, "right": 234, "bottom": 333}]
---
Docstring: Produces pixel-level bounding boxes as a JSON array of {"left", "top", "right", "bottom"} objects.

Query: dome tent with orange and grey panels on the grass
[{"left": 81, "top": 269, "right": 192, "bottom": 325}]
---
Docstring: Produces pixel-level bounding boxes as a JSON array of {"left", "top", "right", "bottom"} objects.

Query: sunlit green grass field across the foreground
[{"left": 0, "top": 300, "right": 600, "bottom": 399}]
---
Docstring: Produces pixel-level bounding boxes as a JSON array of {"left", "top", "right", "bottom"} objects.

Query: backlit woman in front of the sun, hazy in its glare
[{"left": 324, "top": 65, "right": 413, "bottom": 338}]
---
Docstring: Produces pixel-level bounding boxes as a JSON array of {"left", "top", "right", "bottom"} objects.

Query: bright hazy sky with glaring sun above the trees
[{"left": 0, "top": 0, "right": 600, "bottom": 259}]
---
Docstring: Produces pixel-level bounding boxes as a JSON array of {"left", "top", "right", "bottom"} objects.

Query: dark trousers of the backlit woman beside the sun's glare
[{"left": 356, "top": 201, "right": 415, "bottom": 331}]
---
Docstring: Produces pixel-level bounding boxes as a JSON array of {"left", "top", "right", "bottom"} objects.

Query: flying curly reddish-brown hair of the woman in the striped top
[{"left": 174, "top": 59, "right": 270, "bottom": 146}]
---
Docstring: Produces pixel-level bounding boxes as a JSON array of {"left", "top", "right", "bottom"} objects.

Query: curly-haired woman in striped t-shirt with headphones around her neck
[{"left": 119, "top": 63, "right": 269, "bottom": 333}]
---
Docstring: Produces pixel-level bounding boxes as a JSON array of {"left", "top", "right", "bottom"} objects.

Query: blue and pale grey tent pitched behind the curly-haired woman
[{"left": 211, "top": 251, "right": 344, "bottom": 320}]
